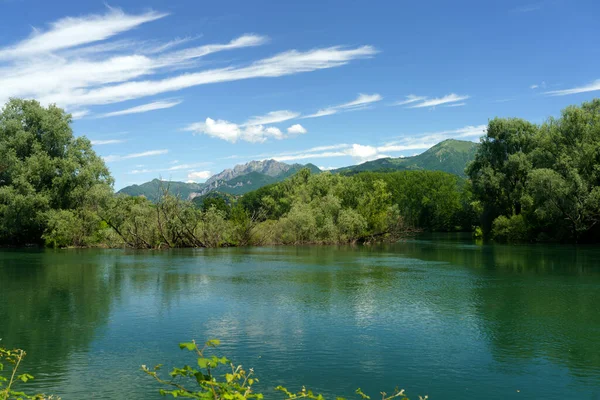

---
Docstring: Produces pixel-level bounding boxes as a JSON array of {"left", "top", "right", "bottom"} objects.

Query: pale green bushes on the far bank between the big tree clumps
[{"left": 99, "top": 169, "right": 407, "bottom": 248}]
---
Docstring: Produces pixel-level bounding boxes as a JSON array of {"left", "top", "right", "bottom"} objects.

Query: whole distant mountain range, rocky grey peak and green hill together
[{"left": 118, "top": 139, "right": 478, "bottom": 202}]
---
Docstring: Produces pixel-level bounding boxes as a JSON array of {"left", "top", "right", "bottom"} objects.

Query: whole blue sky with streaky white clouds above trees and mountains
[{"left": 0, "top": 0, "right": 600, "bottom": 189}]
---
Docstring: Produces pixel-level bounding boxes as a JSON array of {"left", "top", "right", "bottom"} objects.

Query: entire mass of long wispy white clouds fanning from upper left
[{"left": 0, "top": 9, "right": 377, "bottom": 108}]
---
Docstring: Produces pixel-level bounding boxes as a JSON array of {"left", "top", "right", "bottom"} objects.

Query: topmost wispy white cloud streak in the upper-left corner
[{"left": 0, "top": 8, "right": 167, "bottom": 59}]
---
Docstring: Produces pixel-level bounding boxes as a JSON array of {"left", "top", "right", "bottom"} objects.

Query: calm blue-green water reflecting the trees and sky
[{"left": 0, "top": 237, "right": 600, "bottom": 400}]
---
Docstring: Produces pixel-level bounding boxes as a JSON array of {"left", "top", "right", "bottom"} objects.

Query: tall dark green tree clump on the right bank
[{"left": 467, "top": 99, "right": 600, "bottom": 242}]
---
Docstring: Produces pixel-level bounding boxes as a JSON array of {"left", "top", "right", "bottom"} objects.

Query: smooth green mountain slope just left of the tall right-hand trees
[{"left": 333, "top": 139, "right": 478, "bottom": 177}]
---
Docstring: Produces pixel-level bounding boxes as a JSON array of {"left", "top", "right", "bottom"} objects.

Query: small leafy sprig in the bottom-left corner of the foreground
[{"left": 0, "top": 347, "right": 59, "bottom": 400}]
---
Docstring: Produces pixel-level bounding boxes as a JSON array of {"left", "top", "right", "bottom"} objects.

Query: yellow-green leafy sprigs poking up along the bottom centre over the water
[{"left": 142, "top": 340, "right": 427, "bottom": 400}]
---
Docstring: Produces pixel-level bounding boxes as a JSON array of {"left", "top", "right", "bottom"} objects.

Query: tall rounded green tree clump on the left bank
[{"left": 0, "top": 99, "right": 112, "bottom": 245}]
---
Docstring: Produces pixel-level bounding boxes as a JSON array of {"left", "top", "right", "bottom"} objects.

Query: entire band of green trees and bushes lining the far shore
[{"left": 0, "top": 99, "right": 600, "bottom": 249}]
